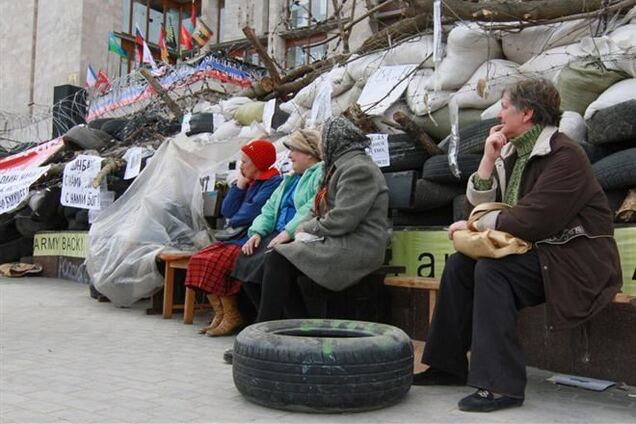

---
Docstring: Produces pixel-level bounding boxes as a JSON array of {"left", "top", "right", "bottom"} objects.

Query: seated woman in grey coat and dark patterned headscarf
[{"left": 246, "top": 117, "right": 389, "bottom": 322}]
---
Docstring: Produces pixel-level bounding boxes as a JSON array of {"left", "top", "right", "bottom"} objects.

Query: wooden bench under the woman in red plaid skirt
[{"left": 159, "top": 252, "right": 211, "bottom": 324}]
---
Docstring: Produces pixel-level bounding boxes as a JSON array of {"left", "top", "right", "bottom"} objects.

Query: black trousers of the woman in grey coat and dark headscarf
[{"left": 241, "top": 250, "right": 307, "bottom": 322}]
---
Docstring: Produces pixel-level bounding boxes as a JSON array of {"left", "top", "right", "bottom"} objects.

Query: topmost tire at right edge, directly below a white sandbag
[{"left": 587, "top": 100, "right": 636, "bottom": 144}]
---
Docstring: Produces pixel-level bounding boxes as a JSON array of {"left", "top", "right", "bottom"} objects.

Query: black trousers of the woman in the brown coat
[{"left": 422, "top": 251, "right": 545, "bottom": 397}]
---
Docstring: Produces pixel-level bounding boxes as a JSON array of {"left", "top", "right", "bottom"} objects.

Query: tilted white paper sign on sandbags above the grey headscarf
[{"left": 358, "top": 65, "right": 417, "bottom": 116}]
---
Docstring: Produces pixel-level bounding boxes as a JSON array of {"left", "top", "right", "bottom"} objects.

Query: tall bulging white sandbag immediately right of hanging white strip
[{"left": 426, "top": 25, "right": 502, "bottom": 90}]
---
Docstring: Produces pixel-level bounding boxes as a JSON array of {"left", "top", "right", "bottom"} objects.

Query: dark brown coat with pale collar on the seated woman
[{"left": 467, "top": 127, "right": 622, "bottom": 330}]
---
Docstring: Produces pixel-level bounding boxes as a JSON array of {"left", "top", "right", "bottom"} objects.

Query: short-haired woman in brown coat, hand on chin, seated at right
[{"left": 413, "top": 80, "right": 622, "bottom": 412}]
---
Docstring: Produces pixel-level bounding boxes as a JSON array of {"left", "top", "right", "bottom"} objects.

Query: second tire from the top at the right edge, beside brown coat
[{"left": 592, "top": 148, "right": 636, "bottom": 191}]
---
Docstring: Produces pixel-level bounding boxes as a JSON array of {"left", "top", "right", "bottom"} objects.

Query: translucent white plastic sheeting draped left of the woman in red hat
[{"left": 86, "top": 134, "right": 241, "bottom": 306}]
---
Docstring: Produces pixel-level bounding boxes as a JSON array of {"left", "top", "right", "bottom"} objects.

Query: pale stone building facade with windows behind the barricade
[{"left": 0, "top": 0, "right": 401, "bottom": 115}]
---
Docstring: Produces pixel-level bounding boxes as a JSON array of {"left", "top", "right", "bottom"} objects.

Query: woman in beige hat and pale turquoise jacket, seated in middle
[{"left": 206, "top": 130, "right": 323, "bottom": 336}]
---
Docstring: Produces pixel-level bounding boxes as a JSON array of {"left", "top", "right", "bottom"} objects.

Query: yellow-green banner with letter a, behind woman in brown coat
[{"left": 391, "top": 226, "right": 636, "bottom": 294}]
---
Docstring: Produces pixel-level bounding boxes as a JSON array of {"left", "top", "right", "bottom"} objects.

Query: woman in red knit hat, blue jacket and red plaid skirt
[{"left": 185, "top": 140, "right": 282, "bottom": 333}]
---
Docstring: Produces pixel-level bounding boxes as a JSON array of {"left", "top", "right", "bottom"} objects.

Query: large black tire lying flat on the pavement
[{"left": 232, "top": 319, "right": 413, "bottom": 413}]
